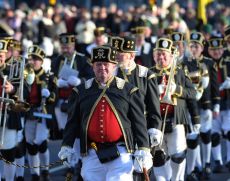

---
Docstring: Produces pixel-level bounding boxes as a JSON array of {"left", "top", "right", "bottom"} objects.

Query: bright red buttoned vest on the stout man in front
[{"left": 88, "top": 97, "right": 123, "bottom": 143}]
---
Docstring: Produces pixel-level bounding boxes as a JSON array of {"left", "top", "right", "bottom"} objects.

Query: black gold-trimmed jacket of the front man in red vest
[{"left": 62, "top": 77, "right": 149, "bottom": 155}]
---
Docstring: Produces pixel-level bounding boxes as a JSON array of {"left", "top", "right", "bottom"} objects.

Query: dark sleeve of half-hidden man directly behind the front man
[{"left": 145, "top": 77, "right": 162, "bottom": 129}]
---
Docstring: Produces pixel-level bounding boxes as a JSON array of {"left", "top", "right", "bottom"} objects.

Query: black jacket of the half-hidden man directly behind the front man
[{"left": 116, "top": 64, "right": 162, "bottom": 129}]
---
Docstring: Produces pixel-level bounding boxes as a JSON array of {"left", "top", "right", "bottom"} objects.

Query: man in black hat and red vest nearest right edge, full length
[{"left": 208, "top": 34, "right": 230, "bottom": 173}]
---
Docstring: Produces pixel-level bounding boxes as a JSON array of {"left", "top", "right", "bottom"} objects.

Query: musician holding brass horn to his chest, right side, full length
[{"left": 184, "top": 32, "right": 220, "bottom": 178}]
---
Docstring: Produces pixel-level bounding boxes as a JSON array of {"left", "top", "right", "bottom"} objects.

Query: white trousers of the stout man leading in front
[{"left": 81, "top": 146, "right": 133, "bottom": 181}]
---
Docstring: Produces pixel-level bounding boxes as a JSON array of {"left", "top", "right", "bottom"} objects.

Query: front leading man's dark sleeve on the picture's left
[{"left": 62, "top": 88, "right": 80, "bottom": 147}]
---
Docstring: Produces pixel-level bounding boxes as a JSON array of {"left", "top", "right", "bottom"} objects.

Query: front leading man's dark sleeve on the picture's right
[{"left": 128, "top": 87, "right": 149, "bottom": 149}]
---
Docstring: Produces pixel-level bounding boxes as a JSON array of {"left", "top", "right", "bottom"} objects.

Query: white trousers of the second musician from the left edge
[{"left": 25, "top": 120, "right": 49, "bottom": 145}]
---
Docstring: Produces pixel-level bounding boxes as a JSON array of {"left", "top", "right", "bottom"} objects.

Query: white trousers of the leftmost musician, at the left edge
[{"left": 0, "top": 127, "right": 17, "bottom": 150}]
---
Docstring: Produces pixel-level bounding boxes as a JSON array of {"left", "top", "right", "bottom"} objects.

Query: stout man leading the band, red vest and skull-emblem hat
[{"left": 59, "top": 46, "right": 152, "bottom": 181}]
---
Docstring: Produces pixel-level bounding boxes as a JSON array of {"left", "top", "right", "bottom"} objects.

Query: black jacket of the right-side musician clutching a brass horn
[{"left": 185, "top": 56, "right": 220, "bottom": 109}]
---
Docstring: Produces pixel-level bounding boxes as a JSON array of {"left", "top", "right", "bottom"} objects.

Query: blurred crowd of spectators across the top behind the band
[{"left": 0, "top": 0, "right": 230, "bottom": 56}]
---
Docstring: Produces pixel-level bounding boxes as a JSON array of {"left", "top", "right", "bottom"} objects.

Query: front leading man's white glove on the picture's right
[{"left": 133, "top": 150, "right": 153, "bottom": 173}]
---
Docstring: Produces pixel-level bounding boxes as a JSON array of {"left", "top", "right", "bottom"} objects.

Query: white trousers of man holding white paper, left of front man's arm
[{"left": 54, "top": 99, "right": 68, "bottom": 130}]
